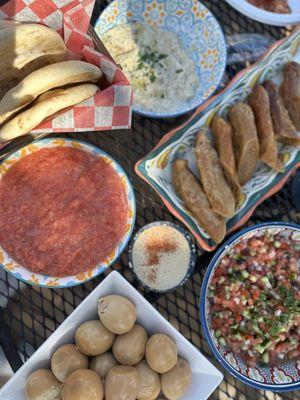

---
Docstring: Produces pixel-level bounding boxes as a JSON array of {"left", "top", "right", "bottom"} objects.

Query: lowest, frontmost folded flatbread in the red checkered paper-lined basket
[{"left": 0, "top": 83, "right": 99, "bottom": 142}]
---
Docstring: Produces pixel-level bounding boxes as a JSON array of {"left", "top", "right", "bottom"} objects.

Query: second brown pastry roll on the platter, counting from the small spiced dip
[{"left": 195, "top": 129, "right": 235, "bottom": 218}]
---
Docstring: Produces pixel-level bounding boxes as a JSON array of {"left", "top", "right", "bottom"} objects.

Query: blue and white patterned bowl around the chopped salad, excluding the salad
[{"left": 200, "top": 222, "right": 300, "bottom": 392}]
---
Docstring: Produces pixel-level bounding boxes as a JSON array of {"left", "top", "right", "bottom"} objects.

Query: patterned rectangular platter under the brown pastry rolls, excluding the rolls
[{"left": 137, "top": 31, "right": 300, "bottom": 250}]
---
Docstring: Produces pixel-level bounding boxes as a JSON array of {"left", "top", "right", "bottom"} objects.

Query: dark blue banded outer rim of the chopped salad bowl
[{"left": 200, "top": 222, "right": 300, "bottom": 392}]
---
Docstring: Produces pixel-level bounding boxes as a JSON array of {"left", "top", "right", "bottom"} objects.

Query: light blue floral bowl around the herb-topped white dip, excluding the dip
[{"left": 95, "top": 0, "right": 227, "bottom": 118}]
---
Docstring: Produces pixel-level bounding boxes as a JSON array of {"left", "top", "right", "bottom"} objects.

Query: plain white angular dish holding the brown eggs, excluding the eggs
[{"left": 0, "top": 271, "right": 223, "bottom": 400}]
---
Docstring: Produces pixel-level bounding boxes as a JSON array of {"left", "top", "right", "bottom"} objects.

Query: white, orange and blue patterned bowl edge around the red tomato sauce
[{"left": 0, "top": 138, "right": 136, "bottom": 288}]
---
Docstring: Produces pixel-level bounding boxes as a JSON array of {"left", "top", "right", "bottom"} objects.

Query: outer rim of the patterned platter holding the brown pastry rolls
[{"left": 135, "top": 28, "right": 300, "bottom": 251}]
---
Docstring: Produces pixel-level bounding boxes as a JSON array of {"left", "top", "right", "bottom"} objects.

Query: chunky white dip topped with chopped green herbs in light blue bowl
[{"left": 101, "top": 23, "right": 200, "bottom": 112}]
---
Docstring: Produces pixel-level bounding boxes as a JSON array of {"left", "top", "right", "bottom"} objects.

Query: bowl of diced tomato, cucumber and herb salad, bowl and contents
[{"left": 200, "top": 222, "right": 300, "bottom": 392}]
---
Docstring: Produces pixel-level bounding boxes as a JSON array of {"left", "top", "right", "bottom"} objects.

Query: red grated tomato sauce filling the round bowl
[{"left": 0, "top": 147, "right": 129, "bottom": 276}]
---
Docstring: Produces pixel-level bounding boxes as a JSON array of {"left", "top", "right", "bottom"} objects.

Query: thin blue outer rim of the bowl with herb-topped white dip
[{"left": 94, "top": 0, "right": 228, "bottom": 119}]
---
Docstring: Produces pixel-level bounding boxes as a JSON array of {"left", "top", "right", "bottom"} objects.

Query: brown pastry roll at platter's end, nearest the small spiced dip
[{"left": 173, "top": 159, "right": 226, "bottom": 243}]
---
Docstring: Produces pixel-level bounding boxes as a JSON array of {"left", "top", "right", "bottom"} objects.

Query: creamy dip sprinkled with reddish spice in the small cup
[{"left": 132, "top": 225, "right": 191, "bottom": 290}]
